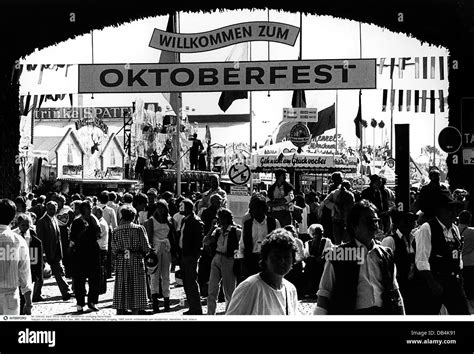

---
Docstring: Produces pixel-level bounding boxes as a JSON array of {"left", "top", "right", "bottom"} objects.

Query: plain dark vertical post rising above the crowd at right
[{"left": 395, "top": 124, "right": 410, "bottom": 211}]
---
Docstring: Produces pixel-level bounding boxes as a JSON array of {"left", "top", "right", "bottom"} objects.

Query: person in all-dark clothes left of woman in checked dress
[{"left": 70, "top": 201, "right": 101, "bottom": 313}]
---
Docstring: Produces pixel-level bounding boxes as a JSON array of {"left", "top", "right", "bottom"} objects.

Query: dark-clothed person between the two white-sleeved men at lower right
[{"left": 381, "top": 210, "right": 417, "bottom": 314}]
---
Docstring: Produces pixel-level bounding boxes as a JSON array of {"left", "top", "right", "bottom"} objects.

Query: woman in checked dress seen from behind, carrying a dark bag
[{"left": 112, "top": 205, "right": 150, "bottom": 315}]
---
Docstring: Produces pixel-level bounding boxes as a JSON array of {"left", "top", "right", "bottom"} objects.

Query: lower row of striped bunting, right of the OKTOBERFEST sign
[{"left": 382, "top": 89, "right": 447, "bottom": 114}]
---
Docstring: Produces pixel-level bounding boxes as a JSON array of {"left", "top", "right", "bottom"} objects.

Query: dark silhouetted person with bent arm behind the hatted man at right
[{"left": 416, "top": 166, "right": 449, "bottom": 219}]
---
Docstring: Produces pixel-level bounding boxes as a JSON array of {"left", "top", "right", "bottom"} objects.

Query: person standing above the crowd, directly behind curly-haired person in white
[{"left": 267, "top": 168, "right": 295, "bottom": 226}]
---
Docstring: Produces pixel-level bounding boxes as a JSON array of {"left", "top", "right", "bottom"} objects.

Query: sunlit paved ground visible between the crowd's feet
[{"left": 32, "top": 273, "right": 316, "bottom": 320}]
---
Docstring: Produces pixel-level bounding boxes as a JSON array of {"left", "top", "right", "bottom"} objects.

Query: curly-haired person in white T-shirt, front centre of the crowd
[{"left": 226, "top": 229, "right": 298, "bottom": 316}]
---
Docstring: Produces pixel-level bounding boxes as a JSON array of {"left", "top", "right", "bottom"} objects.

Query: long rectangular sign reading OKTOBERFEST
[{"left": 78, "top": 59, "right": 377, "bottom": 93}]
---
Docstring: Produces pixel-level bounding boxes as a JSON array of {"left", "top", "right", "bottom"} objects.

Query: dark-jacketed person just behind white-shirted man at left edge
[{"left": 13, "top": 213, "right": 43, "bottom": 315}]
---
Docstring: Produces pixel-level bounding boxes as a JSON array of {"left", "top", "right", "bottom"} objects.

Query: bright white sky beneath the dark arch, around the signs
[{"left": 20, "top": 10, "right": 448, "bottom": 157}]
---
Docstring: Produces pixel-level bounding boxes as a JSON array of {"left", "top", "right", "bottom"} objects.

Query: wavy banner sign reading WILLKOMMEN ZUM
[{"left": 149, "top": 22, "right": 300, "bottom": 53}]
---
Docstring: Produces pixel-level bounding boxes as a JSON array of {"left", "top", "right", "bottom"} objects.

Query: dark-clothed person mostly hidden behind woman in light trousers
[{"left": 198, "top": 194, "right": 222, "bottom": 297}]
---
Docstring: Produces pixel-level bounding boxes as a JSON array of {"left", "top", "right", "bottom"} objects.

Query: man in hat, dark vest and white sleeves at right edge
[{"left": 415, "top": 193, "right": 469, "bottom": 315}]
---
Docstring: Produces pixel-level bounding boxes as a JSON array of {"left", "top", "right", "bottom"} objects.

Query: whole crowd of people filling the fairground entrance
[{"left": 0, "top": 168, "right": 474, "bottom": 315}]
